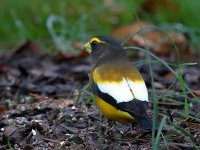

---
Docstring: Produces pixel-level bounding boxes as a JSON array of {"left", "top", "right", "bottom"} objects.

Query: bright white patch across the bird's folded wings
[{"left": 97, "top": 78, "right": 148, "bottom": 103}]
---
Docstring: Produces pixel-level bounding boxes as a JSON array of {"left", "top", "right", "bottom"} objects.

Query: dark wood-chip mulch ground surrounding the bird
[{"left": 0, "top": 33, "right": 200, "bottom": 150}]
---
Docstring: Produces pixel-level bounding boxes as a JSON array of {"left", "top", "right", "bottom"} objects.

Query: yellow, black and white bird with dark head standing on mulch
[{"left": 83, "top": 36, "right": 152, "bottom": 132}]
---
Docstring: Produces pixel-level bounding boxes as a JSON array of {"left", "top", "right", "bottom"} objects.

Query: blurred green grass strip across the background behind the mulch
[{"left": 0, "top": 0, "right": 200, "bottom": 53}]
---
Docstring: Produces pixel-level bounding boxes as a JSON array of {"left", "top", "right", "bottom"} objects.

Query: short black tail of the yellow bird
[{"left": 134, "top": 115, "right": 152, "bottom": 132}]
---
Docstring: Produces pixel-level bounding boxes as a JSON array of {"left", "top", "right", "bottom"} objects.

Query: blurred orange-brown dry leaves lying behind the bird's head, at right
[{"left": 112, "top": 21, "right": 194, "bottom": 57}]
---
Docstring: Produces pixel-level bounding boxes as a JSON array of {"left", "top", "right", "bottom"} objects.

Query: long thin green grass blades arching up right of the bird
[{"left": 125, "top": 26, "right": 199, "bottom": 149}]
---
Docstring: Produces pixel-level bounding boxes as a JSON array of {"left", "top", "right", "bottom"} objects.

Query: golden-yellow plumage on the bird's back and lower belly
[{"left": 90, "top": 64, "right": 144, "bottom": 123}]
